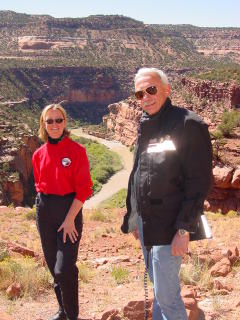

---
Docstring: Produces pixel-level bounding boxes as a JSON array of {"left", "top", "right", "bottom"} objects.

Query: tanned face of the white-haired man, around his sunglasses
[{"left": 135, "top": 74, "right": 170, "bottom": 115}]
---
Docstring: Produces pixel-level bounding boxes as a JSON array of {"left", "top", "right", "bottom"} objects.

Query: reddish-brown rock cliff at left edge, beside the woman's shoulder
[{"left": 0, "top": 111, "right": 40, "bottom": 205}]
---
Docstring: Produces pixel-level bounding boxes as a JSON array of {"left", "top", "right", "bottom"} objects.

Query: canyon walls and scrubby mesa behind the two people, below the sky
[{"left": 0, "top": 11, "right": 240, "bottom": 210}]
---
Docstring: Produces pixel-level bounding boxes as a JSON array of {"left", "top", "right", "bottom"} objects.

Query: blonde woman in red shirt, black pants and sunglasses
[{"left": 32, "top": 104, "right": 92, "bottom": 320}]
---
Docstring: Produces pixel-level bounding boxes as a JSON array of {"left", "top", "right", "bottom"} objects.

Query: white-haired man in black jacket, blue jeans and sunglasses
[{"left": 121, "top": 68, "right": 212, "bottom": 320}]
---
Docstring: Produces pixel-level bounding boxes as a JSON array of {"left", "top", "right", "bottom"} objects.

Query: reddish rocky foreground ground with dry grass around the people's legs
[{"left": 0, "top": 207, "right": 240, "bottom": 320}]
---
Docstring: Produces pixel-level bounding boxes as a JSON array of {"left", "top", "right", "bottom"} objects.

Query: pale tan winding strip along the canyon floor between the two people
[{"left": 72, "top": 128, "right": 133, "bottom": 209}]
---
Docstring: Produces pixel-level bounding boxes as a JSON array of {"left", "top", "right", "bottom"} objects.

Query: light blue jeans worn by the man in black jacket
[{"left": 138, "top": 216, "right": 188, "bottom": 320}]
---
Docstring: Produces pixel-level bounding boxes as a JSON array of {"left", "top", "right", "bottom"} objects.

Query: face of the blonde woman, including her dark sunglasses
[{"left": 44, "top": 109, "right": 66, "bottom": 139}]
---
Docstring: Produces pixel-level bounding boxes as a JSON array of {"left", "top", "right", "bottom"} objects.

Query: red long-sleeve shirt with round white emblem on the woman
[{"left": 32, "top": 137, "right": 92, "bottom": 202}]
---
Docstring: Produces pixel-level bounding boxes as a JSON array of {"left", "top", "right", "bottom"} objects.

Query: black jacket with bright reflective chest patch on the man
[{"left": 121, "top": 98, "right": 212, "bottom": 246}]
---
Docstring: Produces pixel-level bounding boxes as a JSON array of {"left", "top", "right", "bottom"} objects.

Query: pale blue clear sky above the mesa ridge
[{"left": 0, "top": 0, "right": 240, "bottom": 27}]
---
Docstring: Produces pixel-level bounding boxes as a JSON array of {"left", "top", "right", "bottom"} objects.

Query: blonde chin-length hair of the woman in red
[{"left": 38, "top": 104, "right": 70, "bottom": 142}]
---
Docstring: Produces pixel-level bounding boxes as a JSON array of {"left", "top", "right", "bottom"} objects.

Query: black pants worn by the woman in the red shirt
[{"left": 36, "top": 193, "right": 82, "bottom": 320}]
